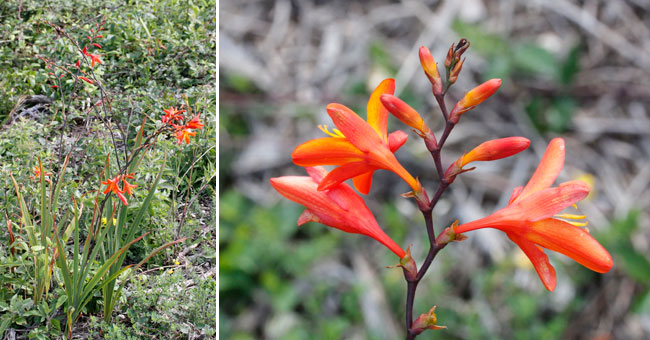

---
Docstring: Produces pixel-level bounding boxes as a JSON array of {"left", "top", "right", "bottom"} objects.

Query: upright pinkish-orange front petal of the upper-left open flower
[{"left": 327, "top": 103, "right": 383, "bottom": 152}]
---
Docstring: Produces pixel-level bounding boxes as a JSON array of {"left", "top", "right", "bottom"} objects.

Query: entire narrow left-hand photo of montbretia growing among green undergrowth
[{"left": 0, "top": 0, "right": 216, "bottom": 339}]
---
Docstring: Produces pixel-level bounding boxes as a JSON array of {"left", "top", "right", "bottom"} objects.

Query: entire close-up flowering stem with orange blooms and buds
[{"left": 270, "top": 39, "right": 613, "bottom": 340}]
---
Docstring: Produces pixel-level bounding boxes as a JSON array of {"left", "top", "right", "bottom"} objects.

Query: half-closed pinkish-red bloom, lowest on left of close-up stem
[{"left": 271, "top": 167, "right": 406, "bottom": 258}]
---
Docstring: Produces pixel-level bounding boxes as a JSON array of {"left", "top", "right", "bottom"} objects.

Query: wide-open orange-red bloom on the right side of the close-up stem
[{"left": 454, "top": 138, "right": 613, "bottom": 291}]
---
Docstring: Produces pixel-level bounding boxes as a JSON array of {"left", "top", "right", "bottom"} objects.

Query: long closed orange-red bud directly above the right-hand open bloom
[{"left": 445, "top": 137, "right": 530, "bottom": 181}]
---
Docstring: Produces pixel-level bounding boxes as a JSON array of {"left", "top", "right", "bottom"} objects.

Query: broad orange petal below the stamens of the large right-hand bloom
[{"left": 522, "top": 218, "right": 614, "bottom": 273}]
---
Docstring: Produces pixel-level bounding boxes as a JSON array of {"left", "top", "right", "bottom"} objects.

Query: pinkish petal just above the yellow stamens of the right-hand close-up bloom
[{"left": 503, "top": 181, "right": 589, "bottom": 222}]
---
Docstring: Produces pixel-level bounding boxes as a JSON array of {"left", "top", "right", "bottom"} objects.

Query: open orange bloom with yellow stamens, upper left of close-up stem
[{"left": 291, "top": 79, "right": 422, "bottom": 194}]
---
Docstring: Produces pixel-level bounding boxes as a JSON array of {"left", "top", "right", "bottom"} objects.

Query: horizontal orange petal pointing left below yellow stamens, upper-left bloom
[{"left": 291, "top": 137, "right": 364, "bottom": 166}]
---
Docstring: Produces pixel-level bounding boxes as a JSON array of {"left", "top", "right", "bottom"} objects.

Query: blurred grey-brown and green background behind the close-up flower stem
[{"left": 219, "top": 0, "right": 650, "bottom": 339}]
